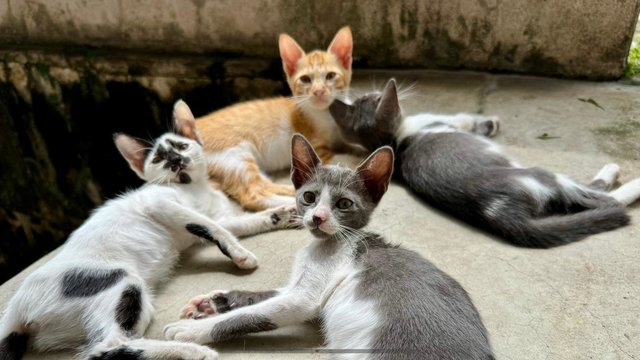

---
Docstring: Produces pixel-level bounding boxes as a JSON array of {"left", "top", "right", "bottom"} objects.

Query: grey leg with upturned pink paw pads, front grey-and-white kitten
[{"left": 180, "top": 290, "right": 278, "bottom": 319}]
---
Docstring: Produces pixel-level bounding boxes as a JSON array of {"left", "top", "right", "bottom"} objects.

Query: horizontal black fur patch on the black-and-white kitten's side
[{"left": 62, "top": 268, "right": 127, "bottom": 297}]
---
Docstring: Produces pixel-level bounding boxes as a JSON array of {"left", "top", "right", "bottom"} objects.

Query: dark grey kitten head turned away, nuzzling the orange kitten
[{"left": 329, "top": 79, "right": 402, "bottom": 150}]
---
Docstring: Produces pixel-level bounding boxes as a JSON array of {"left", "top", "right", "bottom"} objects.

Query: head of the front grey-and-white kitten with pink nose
[{"left": 291, "top": 134, "right": 393, "bottom": 238}]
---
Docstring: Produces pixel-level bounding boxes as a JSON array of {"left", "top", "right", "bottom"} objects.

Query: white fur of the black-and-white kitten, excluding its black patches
[{"left": 0, "top": 116, "right": 295, "bottom": 359}]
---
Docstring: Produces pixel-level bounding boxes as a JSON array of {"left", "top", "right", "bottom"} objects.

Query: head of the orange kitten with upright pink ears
[{"left": 279, "top": 27, "right": 353, "bottom": 109}]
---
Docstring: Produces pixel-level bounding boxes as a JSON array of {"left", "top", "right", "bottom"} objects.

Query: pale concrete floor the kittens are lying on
[{"left": 0, "top": 71, "right": 640, "bottom": 359}]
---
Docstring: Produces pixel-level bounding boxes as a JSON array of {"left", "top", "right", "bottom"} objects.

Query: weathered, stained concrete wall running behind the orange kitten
[{"left": 0, "top": 0, "right": 640, "bottom": 79}]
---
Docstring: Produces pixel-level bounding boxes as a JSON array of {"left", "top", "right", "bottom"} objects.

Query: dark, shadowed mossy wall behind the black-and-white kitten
[{"left": 0, "top": 47, "right": 286, "bottom": 283}]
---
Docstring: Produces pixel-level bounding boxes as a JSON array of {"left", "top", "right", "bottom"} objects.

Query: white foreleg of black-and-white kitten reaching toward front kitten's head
[{"left": 218, "top": 205, "right": 301, "bottom": 236}]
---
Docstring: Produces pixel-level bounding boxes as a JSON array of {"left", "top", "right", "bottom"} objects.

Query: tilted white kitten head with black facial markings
[{"left": 114, "top": 100, "right": 207, "bottom": 184}]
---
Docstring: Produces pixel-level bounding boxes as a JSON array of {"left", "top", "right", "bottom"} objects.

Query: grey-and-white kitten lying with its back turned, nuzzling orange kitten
[{"left": 330, "top": 79, "right": 640, "bottom": 248}]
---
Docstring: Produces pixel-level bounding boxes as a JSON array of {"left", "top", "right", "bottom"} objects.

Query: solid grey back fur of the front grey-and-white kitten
[{"left": 358, "top": 234, "right": 493, "bottom": 360}]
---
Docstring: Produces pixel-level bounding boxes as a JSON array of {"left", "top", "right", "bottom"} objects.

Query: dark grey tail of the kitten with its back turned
[{"left": 491, "top": 206, "right": 631, "bottom": 248}]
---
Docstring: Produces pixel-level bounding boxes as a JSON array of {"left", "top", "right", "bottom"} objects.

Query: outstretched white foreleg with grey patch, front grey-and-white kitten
[{"left": 164, "top": 293, "right": 318, "bottom": 344}]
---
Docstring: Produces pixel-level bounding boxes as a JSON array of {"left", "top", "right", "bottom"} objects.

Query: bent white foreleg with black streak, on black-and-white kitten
[{"left": 147, "top": 199, "right": 258, "bottom": 269}]
